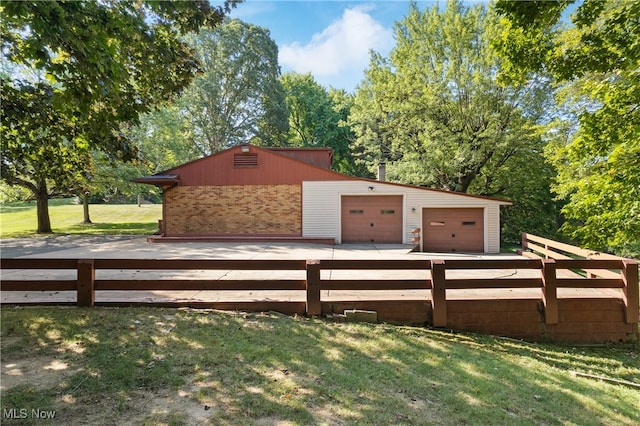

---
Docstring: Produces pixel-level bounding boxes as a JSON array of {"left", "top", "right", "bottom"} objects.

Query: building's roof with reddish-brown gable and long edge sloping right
[{"left": 132, "top": 145, "right": 512, "bottom": 205}]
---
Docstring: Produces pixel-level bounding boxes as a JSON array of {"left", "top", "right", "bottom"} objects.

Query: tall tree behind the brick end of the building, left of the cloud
[{"left": 129, "top": 19, "right": 288, "bottom": 161}]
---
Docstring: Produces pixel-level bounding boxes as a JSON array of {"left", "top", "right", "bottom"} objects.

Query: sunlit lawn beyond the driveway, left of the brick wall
[{"left": 0, "top": 199, "right": 162, "bottom": 238}]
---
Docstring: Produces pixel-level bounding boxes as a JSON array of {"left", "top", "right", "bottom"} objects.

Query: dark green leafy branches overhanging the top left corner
[{"left": 1, "top": 1, "right": 235, "bottom": 159}]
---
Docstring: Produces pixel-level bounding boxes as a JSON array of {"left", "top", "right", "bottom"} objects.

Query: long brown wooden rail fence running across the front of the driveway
[{"left": 0, "top": 258, "right": 640, "bottom": 327}]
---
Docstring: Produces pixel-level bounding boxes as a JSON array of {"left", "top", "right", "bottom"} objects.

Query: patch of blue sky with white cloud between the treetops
[{"left": 230, "top": 0, "right": 446, "bottom": 92}]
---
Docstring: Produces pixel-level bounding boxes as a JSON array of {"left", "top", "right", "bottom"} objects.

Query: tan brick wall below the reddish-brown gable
[{"left": 164, "top": 185, "right": 302, "bottom": 236}]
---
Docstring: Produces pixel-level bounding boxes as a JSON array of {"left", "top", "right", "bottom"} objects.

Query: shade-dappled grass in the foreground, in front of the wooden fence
[{"left": 0, "top": 307, "right": 640, "bottom": 425}]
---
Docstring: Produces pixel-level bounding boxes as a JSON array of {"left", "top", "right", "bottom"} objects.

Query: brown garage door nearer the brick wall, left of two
[{"left": 342, "top": 195, "right": 402, "bottom": 243}]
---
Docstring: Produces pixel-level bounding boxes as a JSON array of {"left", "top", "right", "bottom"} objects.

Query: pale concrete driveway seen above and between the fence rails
[{"left": 0, "top": 236, "right": 611, "bottom": 303}]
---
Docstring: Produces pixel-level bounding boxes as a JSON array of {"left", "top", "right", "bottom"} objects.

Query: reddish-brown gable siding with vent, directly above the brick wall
[{"left": 168, "top": 146, "right": 355, "bottom": 186}]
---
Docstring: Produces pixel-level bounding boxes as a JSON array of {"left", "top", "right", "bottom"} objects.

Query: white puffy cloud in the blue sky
[{"left": 279, "top": 6, "right": 393, "bottom": 81}]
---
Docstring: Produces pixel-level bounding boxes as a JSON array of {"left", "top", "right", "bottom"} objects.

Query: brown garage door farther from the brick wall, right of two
[{"left": 422, "top": 208, "right": 484, "bottom": 253}]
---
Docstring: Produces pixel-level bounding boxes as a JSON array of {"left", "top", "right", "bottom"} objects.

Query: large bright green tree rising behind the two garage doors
[{"left": 349, "top": 1, "right": 557, "bottom": 238}]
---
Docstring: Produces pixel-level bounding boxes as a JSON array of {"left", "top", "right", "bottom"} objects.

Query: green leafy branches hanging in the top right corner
[{"left": 494, "top": 0, "right": 640, "bottom": 80}]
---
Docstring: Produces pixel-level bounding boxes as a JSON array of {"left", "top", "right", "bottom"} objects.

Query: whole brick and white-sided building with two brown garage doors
[{"left": 134, "top": 145, "right": 511, "bottom": 253}]
